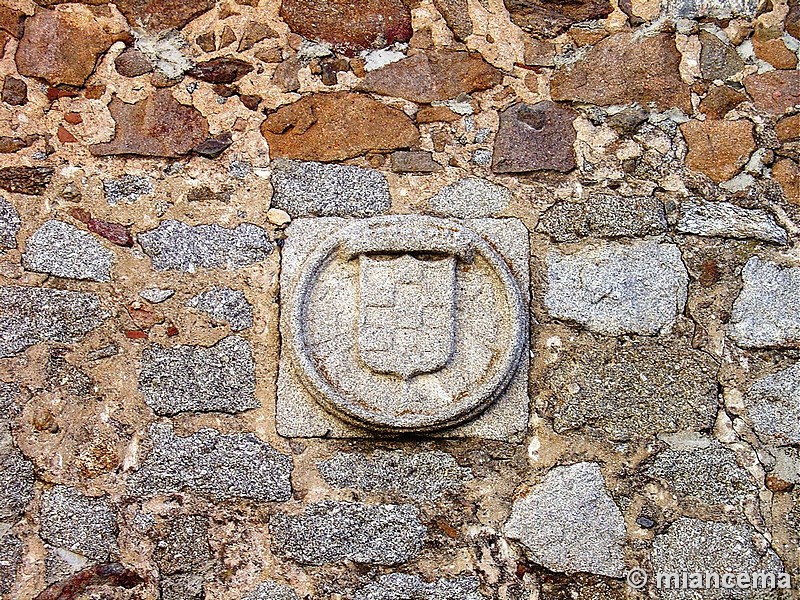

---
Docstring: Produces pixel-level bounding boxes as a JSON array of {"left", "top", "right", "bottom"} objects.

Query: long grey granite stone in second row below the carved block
[{"left": 269, "top": 501, "right": 427, "bottom": 565}]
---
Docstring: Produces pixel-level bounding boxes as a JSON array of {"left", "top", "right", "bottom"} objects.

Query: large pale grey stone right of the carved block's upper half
[{"left": 544, "top": 241, "right": 689, "bottom": 335}]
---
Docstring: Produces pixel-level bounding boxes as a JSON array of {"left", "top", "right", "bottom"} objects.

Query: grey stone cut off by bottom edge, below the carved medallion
[{"left": 353, "top": 573, "right": 484, "bottom": 600}]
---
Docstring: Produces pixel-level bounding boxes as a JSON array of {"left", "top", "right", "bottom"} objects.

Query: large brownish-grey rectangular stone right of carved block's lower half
[{"left": 547, "top": 338, "right": 717, "bottom": 440}]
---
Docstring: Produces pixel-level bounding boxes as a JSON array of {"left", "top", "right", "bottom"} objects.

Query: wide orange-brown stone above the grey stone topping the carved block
[{"left": 261, "top": 92, "right": 419, "bottom": 162}]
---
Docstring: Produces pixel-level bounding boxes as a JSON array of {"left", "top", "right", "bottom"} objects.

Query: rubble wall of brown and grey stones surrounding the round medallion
[{"left": 0, "top": 0, "right": 800, "bottom": 600}]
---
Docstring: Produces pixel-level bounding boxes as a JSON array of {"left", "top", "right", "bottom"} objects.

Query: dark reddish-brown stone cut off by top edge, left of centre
[{"left": 280, "top": 0, "right": 412, "bottom": 55}]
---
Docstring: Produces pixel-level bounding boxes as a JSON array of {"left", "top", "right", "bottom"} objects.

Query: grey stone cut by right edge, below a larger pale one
[{"left": 744, "top": 362, "right": 800, "bottom": 446}]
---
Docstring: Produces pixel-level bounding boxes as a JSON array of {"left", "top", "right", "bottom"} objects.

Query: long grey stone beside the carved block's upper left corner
[{"left": 137, "top": 219, "right": 272, "bottom": 273}]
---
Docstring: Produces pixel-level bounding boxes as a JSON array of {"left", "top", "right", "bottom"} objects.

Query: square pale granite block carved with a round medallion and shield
[{"left": 277, "top": 215, "right": 529, "bottom": 440}]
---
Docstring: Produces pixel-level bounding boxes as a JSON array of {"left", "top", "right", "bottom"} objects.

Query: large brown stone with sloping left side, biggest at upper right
[{"left": 550, "top": 33, "right": 691, "bottom": 114}]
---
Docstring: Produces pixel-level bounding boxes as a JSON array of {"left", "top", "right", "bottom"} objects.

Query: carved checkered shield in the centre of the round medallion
[{"left": 358, "top": 254, "right": 456, "bottom": 379}]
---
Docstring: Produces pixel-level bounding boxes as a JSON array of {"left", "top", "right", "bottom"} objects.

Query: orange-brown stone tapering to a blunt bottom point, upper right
[{"left": 681, "top": 119, "right": 756, "bottom": 183}]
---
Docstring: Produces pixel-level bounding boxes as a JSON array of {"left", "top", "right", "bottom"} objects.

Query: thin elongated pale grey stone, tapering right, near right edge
[{"left": 677, "top": 199, "right": 788, "bottom": 244}]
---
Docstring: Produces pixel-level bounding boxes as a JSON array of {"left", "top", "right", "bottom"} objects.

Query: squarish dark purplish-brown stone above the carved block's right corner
[{"left": 492, "top": 101, "right": 577, "bottom": 173}]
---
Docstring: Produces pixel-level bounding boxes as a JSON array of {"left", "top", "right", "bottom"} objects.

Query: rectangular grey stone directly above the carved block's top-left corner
[{"left": 272, "top": 160, "right": 391, "bottom": 217}]
